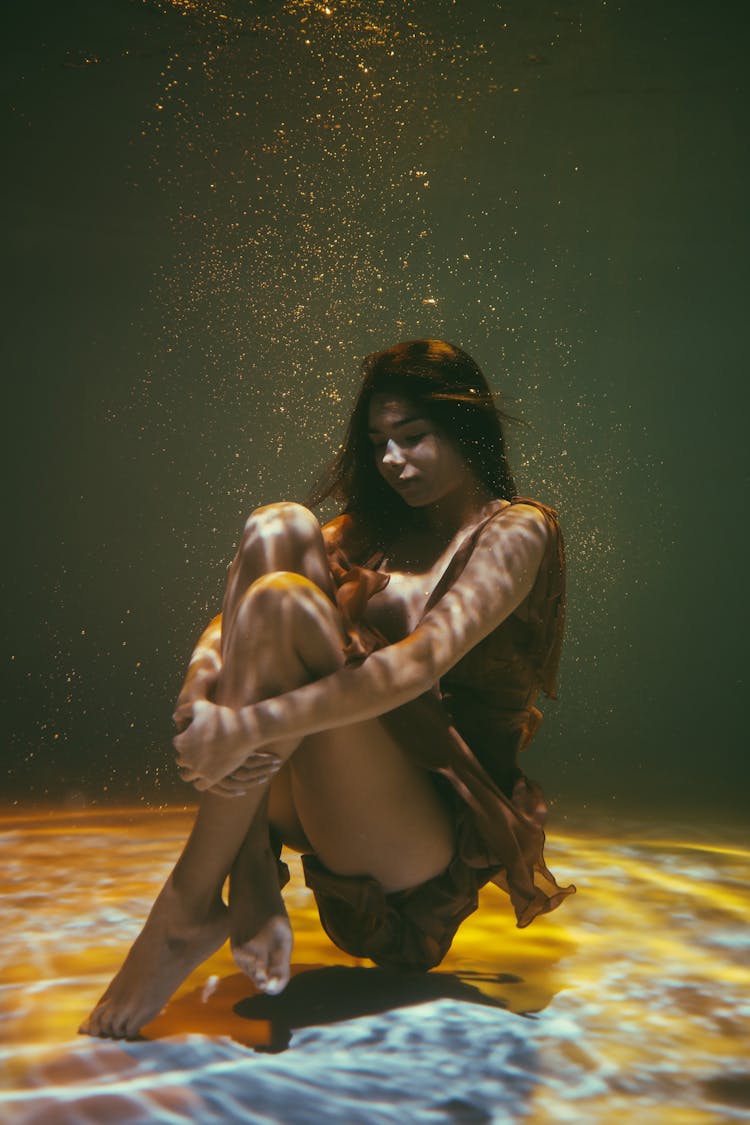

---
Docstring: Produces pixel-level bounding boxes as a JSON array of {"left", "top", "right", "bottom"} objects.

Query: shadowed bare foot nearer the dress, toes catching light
[{"left": 229, "top": 838, "right": 293, "bottom": 995}]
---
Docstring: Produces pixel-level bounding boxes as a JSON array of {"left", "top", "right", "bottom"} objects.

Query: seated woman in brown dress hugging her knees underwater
[{"left": 81, "top": 340, "right": 573, "bottom": 1036}]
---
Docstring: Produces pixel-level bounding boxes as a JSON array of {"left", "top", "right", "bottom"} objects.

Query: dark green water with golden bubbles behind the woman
[{"left": 1, "top": 0, "right": 750, "bottom": 815}]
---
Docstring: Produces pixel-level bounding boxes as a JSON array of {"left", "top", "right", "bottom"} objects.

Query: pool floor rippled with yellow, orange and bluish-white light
[{"left": 0, "top": 810, "right": 750, "bottom": 1125}]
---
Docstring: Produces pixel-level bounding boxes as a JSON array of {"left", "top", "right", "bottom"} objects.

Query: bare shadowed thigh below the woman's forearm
[{"left": 291, "top": 705, "right": 455, "bottom": 893}]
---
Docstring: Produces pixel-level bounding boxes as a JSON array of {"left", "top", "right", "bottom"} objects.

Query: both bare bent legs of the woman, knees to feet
[{"left": 81, "top": 505, "right": 453, "bottom": 1036}]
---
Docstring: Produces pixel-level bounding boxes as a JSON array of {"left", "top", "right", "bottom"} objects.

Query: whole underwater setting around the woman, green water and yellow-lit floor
[{"left": 0, "top": 0, "right": 750, "bottom": 1125}]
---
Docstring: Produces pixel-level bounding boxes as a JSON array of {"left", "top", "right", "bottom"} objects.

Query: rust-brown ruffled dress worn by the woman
[{"left": 302, "top": 497, "right": 575, "bottom": 970}]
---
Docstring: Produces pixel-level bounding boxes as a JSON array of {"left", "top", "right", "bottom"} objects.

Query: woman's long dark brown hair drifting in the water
[{"left": 308, "top": 340, "right": 515, "bottom": 548}]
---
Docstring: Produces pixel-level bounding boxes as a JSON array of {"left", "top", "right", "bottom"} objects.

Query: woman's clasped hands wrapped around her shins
[{"left": 173, "top": 700, "right": 281, "bottom": 797}]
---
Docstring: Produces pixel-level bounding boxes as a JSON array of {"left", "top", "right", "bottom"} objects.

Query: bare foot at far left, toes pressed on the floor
[{"left": 79, "top": 876, "right": 228, "bottom": 1038}]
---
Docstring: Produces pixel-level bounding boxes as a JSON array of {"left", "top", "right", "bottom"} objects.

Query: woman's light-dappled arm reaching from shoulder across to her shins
[{"left": 174, "top": 505, "right": 548, "bottom": 788}]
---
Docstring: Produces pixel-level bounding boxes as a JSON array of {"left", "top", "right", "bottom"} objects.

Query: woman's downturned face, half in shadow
[{"left": 368, "top": 394, "right": 473, "bottom": 507}]
